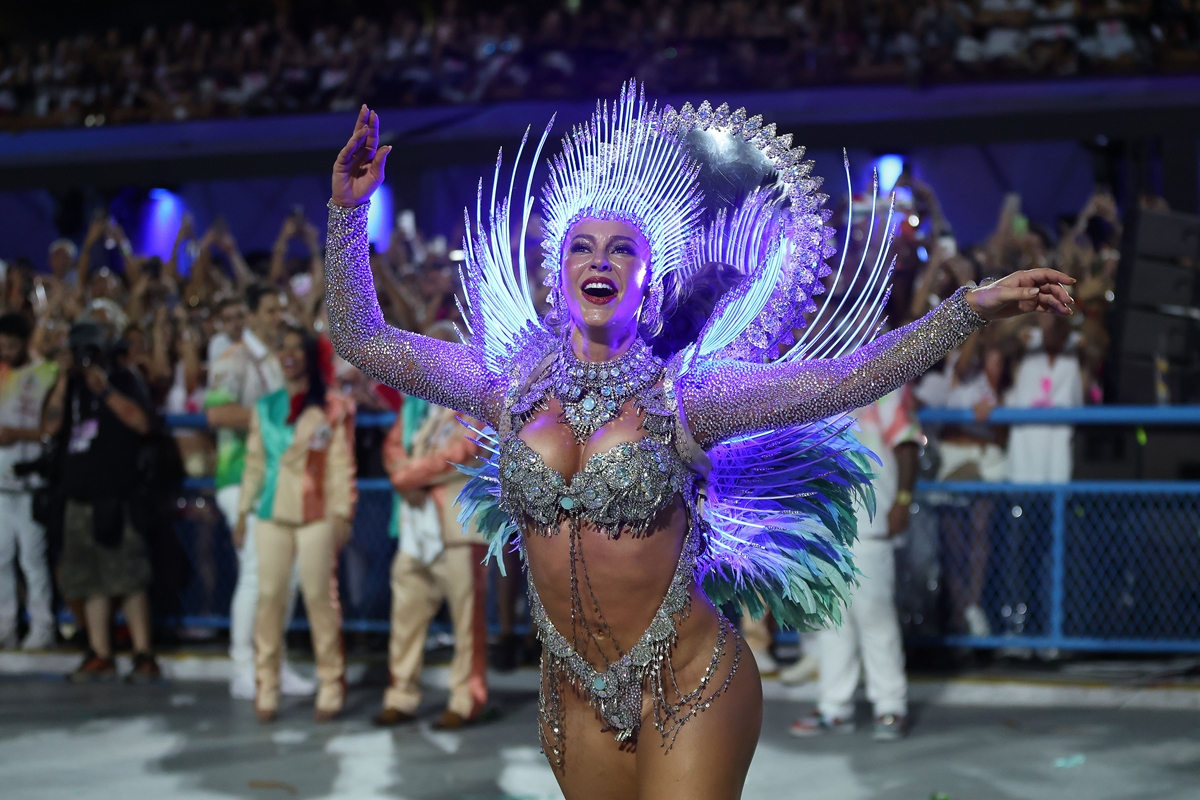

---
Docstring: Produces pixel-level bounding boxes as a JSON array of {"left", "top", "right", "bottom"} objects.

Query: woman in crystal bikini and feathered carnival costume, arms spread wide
[{"left": 326, "top": 83, "right": 1072, "bottom": 800}]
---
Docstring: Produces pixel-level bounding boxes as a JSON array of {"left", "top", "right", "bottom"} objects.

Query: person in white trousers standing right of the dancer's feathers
[{"left": 791, "top": 386, "right": 922, "bottom": 741}]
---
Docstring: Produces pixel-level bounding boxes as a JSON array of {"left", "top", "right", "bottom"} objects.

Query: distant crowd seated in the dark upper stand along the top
[{"left": 0, "top": 0, "right": 1200, "bottom": 130}]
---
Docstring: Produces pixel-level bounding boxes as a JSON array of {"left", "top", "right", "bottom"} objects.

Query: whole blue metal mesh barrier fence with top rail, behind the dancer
[{"left": 159, "top": 407, "right": 1200, "bottom": 652}]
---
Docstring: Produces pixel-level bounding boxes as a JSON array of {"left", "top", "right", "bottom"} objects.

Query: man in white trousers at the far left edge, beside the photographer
[{"left": 0, "top": 312, "right": 58, "bottom": 650}]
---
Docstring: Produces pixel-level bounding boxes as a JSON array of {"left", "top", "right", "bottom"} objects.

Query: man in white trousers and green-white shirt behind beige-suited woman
[{"left": 204, "top": 285, "right": 317, "bottom": 700}]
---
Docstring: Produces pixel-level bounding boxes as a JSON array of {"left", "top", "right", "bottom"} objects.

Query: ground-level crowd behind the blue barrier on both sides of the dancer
[{"left": 0, "top": 155, "right": 1152, "bottom": 662}]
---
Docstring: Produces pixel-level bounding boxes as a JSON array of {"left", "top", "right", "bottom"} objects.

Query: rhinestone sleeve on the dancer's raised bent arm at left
[{"left": 325, "top": 201, "right": 503, "bottom": 425}]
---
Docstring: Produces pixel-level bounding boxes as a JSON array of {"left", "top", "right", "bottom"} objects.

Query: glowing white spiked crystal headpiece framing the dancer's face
[{"left": 542, "top": 80, "right": 703, "bottom": 327}]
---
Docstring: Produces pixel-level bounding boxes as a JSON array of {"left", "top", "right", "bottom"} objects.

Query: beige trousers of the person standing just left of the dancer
[{"left": 383, "top": 545, "right": 487, "bottom": 720}]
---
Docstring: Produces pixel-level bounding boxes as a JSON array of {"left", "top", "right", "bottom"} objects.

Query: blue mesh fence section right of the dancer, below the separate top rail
[{"left": 916, "top": 481, "right": 1200, "bottom": 652}]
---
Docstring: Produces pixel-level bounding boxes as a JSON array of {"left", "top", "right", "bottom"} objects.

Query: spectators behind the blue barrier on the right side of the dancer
[{"left": 893, "top": 174, "right": 1147, "bottom": 642}]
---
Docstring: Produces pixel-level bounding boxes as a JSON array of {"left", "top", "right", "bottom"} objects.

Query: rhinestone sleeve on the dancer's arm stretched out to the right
[{"left": 680, "top": 289, "right": 984, "bottom": 450}]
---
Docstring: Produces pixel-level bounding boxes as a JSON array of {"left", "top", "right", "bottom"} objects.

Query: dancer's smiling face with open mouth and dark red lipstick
[{"left": 562, "top": 218, "right": 650, "bottom": 331}]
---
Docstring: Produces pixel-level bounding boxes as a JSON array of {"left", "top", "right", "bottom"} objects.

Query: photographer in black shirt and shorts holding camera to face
[{"left": 42, "top": 321, "right": 161, "bottom": 682}]
